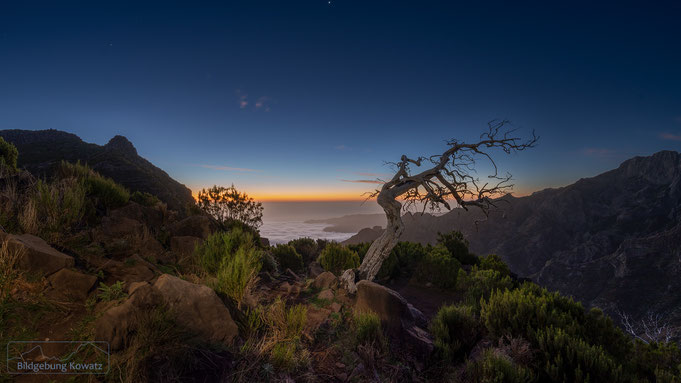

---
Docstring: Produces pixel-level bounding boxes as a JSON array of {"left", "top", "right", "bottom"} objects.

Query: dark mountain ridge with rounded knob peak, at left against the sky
[{"left": 0, "top": 129, "right": 194, "bottom": 211}]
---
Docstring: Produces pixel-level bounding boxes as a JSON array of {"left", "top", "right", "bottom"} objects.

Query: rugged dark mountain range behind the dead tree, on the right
[{"left": 346, "top": 151, "right": 681, "bottom": 324}]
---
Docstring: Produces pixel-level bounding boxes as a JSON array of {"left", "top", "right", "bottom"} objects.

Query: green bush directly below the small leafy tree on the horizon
[{"left": 194, "top": 227, "right": 255, "bottom": 274}]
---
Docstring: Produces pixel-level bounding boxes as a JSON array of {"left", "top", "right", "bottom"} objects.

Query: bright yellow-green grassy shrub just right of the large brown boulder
[{"left": 212, "top": 246, "right": 262, "bottom": 308}]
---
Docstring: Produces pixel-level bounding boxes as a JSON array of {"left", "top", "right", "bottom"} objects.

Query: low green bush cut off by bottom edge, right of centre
[{"left": 466, "top": 349, "right": 532, "bottom": 383}]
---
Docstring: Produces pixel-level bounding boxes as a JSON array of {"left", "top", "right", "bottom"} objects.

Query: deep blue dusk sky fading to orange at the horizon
[{"left": 0, "top": 0, "right": 681, "bottom": 199}]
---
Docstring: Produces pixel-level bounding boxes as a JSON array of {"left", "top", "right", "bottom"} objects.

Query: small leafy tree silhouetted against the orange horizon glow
[{"left": 198, "top": 185, "right": 263, "bottom": 229}]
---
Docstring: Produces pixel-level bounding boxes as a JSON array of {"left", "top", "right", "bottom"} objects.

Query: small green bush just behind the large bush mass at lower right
[{"left": 457, "top": 267, "right": 513, "bottom": 312}]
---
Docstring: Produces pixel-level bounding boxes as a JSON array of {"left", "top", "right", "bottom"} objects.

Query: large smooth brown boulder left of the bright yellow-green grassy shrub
[{"left": 153, "top": 274, "right": 239, "bottom": 344}]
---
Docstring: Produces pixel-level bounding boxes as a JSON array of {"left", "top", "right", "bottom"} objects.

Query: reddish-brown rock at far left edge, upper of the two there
[{"left": 6, "top": 234, "right": 75, "bottom": 275}]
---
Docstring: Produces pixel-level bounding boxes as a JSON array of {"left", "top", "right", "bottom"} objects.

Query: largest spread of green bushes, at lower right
[{"left": 480, "top": 283, "right": 638, "bottom": 382}]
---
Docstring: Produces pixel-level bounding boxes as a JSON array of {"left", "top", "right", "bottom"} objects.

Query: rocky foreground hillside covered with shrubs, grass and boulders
[{"left": 0, "top": 140, "right": 681, "bottom": 383}]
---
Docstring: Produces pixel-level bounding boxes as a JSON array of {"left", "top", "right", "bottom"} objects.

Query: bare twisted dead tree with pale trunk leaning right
[{"left": 341, "top": 120, "right": 539, "bottom": 293}]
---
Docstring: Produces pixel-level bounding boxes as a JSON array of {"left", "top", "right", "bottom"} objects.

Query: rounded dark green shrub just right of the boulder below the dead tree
[{"left": 430, "top": 305, "right": 480, "bottom": 360}]
